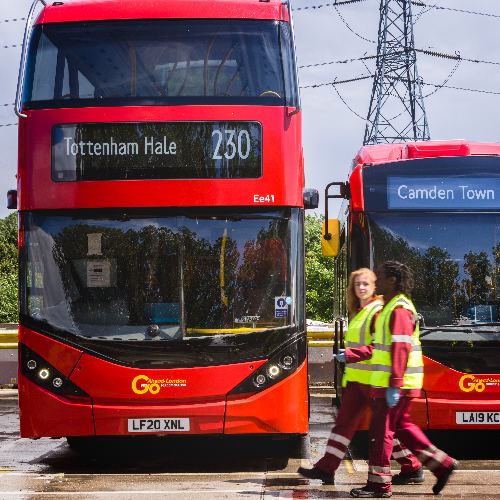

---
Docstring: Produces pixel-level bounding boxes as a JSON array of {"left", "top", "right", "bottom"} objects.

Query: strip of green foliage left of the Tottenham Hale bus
[{"left": 0, "top": 212, "right": 18, "bottom": 323}]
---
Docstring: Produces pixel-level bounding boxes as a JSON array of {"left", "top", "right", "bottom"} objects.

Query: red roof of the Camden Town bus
[{"left": 353, "top": 140, "right": 500, "bottom": 170}]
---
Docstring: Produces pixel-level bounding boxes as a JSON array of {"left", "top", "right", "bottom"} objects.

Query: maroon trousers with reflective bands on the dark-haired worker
[{"left": 367, "top": 396, "right": 454, "bottom": 491}]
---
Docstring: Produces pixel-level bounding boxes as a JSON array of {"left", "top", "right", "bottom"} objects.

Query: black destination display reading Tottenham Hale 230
[{"left": 52, "top": 121, "right": 262, "bottom": 182}]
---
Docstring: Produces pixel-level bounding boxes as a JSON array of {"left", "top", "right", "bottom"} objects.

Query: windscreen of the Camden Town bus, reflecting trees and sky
[{"left": 370, "top": 213, "right": 500, "bottom": 327}]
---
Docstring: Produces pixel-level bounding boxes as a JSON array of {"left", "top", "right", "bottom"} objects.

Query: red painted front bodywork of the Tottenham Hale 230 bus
[{"left": 18, "top": 0, "right": 308, "bottom": 437}]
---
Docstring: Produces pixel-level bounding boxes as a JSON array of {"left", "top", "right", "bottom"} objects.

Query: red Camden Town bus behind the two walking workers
[{"left": 322, "top": 141, "right": 500, "bottom": 429}]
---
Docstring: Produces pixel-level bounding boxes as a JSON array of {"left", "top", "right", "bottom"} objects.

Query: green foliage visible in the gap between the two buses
[{"left": 305, "top": 214, "right": 335, "bottom": 322}]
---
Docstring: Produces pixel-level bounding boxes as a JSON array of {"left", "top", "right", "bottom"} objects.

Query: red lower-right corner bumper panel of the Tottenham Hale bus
[{"left": 224, "top": 358, "right": 308, "bottom": 434}]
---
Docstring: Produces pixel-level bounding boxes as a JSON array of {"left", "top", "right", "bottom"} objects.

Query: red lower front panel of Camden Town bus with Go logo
[{"left": 424, "top": 356, "right": 500, "bottom": 429}]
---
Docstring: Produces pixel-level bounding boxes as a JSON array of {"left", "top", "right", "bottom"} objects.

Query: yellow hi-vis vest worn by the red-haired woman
[{"left": 342, "top": 300, "right": 384, "bottom": 387}]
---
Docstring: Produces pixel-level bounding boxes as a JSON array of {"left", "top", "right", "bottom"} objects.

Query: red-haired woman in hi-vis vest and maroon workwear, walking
[{"left": 298, "top": 268, "right": 424, "bottom": 484}]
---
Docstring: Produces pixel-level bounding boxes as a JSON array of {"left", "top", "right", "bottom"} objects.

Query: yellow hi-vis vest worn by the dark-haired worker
[{"left": 370, "top": 294, "right": 424, "bottom": 389}]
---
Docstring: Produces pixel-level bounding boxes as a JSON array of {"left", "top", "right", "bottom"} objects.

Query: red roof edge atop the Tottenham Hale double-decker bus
[{"left": 37, "top": 0, "right": 288, "bottom": 24}]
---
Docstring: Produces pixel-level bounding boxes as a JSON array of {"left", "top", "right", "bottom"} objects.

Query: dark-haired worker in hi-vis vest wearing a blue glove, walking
[{"left": 350, "top": 261, "right": 458, "bottom": 498}]
